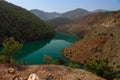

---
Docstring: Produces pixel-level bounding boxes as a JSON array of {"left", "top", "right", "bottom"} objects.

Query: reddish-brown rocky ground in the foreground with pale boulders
[{"left": 0, "top": 65, "right": 105, "bottom": 80}]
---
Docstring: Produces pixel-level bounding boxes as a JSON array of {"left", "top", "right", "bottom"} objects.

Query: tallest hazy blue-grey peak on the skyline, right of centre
[{"left": 61, "top": 8, "right": 90, "bottom": 20}]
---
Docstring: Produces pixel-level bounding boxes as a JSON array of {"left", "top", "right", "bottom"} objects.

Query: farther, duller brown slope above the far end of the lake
[{"left": 55, "top": 12, "right": 119, "bottom": 36}]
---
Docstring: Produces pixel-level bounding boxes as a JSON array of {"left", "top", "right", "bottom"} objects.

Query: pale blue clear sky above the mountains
[{"left": 6, "top": 0, "right": 120, "bottom": 13}]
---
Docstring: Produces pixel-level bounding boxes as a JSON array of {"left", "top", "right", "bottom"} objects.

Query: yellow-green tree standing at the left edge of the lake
[{"left": 2, "top": 37, "right": 22, "bottom": 64}]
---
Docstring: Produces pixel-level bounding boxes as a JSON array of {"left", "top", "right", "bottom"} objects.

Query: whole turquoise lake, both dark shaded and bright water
[{"left": 12, "top": 33, "right": 78, "bottom": 65}]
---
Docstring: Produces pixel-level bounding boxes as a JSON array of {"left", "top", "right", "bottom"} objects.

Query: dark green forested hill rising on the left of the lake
[{"left": 0, "top": 0, "right": 54, "bottom": 44}]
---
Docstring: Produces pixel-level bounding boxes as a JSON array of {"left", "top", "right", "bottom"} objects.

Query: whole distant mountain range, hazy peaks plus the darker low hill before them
[{"left": 30, "top": 8, "right": 107, "bottom": 28}]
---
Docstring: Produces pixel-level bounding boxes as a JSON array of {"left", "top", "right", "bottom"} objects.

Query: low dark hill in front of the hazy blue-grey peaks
[{"left": 45, "top": 17, "right": 72, "bottom": 28}]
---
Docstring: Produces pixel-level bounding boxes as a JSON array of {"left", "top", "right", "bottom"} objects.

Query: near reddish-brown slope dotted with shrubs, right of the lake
[{"left": 63, "top": 11, "right": 120, "bottom": 70}]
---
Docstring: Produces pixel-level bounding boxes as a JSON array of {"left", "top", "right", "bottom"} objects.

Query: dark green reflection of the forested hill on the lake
[{"left": 14, "top": 39, "right": 51, "bottom": 60}]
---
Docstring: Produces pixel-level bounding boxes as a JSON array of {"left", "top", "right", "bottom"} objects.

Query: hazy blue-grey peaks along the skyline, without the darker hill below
[{"left": 30, "top": 8, "right": 107, "bottom": 20}]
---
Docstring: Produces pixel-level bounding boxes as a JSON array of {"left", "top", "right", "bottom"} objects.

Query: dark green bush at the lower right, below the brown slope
[{"left": 85, "top": 59, "right": 116, "bottom": 80}]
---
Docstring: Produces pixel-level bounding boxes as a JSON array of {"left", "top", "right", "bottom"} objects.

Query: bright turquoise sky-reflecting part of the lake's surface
[{"left": 18, "top": 40, "right": 71, "bottom": 64}]
